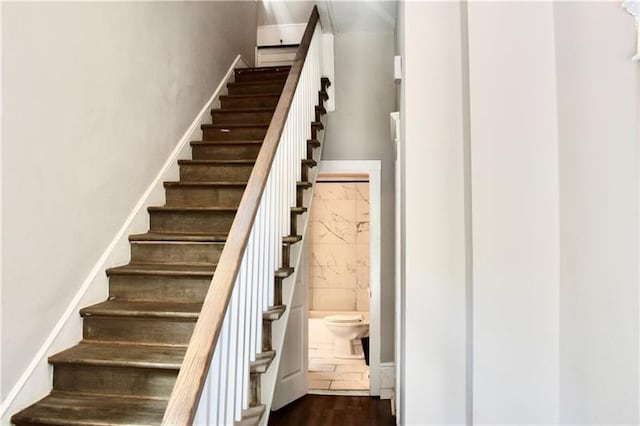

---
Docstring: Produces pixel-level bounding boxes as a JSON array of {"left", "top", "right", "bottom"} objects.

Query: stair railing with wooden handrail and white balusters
[{"left": 162, "top": 7, "right": 322, "bottom": 426}]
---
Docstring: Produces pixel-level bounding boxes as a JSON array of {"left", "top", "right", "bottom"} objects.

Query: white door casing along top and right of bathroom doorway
[{"left": 318, "top": 160, "right": 382, "bottom": 396}]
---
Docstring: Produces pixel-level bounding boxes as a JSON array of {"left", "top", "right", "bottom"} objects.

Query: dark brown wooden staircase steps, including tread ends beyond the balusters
[{"left": 12, "top": 61, "right": 330, "bottom": 426}]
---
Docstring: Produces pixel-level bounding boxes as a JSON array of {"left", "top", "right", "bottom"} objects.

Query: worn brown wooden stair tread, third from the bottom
[{"left": 80, "top": 299, "right": 202, "bottom": 320}]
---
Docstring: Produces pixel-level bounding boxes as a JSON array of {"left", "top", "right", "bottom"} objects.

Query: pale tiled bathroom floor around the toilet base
[{"left": 309, "top": 348, "right": 369, "bottom": 391}]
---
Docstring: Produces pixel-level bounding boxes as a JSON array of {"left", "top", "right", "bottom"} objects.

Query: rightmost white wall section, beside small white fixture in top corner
[{"left": 554, "top": 3, "right": 639, "bottom": 424}]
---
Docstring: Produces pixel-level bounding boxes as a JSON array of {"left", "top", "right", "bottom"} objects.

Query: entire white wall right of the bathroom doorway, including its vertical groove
[{"left": 397, "top": 2, "right": 640, "bottom": 425}]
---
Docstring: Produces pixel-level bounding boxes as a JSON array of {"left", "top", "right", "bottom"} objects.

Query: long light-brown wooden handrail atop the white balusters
[{"left": 162, "top": 6, "right": 319, "bottom": 426}]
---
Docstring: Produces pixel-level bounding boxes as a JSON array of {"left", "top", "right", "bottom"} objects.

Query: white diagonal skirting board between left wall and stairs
[{"left": 0, "top": 55, "right": 247, "bottom": 424}]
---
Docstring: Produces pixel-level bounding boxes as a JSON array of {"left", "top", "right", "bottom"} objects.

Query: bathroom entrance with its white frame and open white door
[{"left": 271, "top": 160, "right": 381, "bottom": 410}]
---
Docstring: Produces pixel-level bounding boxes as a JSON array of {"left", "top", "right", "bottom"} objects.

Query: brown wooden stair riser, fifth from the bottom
[{"left": 150, "top": 211, "right": 235, "bottom": 234}]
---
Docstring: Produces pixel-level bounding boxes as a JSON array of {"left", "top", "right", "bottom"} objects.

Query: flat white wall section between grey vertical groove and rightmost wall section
[{"left": 468, "top": 2, "right": 559, "bottom": 424}]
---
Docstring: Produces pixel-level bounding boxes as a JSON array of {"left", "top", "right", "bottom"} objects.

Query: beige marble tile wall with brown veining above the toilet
[{"left": 309, "top": 182, "right": 369, "bottom": 311}]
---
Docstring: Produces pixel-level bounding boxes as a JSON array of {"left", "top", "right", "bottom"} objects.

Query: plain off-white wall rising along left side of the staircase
[{"left": 0, "top": 2, "right": 257, "bottom": 398}]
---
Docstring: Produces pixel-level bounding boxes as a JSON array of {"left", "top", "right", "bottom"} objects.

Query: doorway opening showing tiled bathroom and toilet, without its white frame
[{"left": 307, "top": 173, "right": 371, "bottom": 395}]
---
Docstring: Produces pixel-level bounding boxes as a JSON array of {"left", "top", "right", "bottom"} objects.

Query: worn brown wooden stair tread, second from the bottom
[{"left": 49, "top": 342, "right": 187, "bottom": 370}]
